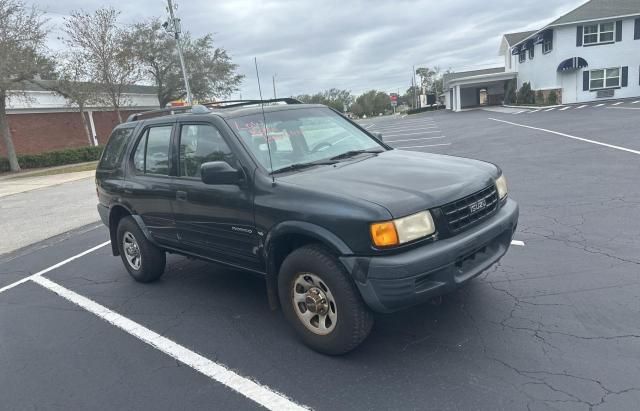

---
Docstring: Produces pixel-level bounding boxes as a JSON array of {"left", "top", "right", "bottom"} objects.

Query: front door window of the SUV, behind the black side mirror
[{"left": 178, "top": 124, "right": 236, "bottom": 178}]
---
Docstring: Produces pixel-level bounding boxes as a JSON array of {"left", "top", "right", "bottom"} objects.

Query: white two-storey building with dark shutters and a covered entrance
[{"left": 445, "top": 0, "right": 640, "bottom": 111}]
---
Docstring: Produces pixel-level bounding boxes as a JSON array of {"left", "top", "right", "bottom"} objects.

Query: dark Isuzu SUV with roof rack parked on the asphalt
[{"left": 96, "top": 99, "right": 518, "bottom": 354}]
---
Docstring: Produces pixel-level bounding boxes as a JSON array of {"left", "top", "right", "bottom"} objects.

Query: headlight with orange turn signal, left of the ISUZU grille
[{"left": 371, "top": 211, "right": 436, "bottom": 247}]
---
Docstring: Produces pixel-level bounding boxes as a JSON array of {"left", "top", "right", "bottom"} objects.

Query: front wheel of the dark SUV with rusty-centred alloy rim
[{"left": 278, "top": 245, "right": 373, "bottom": 355}]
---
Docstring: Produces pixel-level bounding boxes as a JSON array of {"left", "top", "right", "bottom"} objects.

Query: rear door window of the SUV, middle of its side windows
[{"left": 133, "top": 126, "right": 173, "bottom": 176}]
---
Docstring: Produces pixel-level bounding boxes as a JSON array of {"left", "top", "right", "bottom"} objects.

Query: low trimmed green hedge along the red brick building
[{"left": 0, "top": 146, "right": 102, "bottom": 172}]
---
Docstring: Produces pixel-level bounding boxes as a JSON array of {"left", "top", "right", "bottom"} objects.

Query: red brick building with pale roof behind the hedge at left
[{"left": 0, "top": 83, "right": 159, "bottom": 157}]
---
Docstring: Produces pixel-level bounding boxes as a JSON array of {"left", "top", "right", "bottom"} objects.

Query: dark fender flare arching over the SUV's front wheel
[{"left": 264, "top": 221, "right": 353, "bottom": 310}]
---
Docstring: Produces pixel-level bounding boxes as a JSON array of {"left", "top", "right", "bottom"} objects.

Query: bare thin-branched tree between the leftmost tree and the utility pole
[{"left": 64, "top": 7, "right": 140, "bottom": 123}]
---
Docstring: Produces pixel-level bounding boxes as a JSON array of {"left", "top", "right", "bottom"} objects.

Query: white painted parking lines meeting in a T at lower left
[{"left": 0, "top": 241, "right": 309, "bottom": 410}]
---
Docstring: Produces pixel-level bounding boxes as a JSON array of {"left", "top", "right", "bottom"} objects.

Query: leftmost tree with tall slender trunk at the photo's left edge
[{"left": 0, "top": 0, "right": 50, "bottom": 171}]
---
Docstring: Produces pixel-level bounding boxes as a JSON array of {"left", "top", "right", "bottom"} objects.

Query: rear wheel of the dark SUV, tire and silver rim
[{"left": 116, "top": 216, "right": 167, "bottom": 283}]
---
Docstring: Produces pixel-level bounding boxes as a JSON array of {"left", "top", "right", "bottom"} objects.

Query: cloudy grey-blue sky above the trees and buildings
[{"left": 35, "top": 0, "right": 585, "bottom": 98}]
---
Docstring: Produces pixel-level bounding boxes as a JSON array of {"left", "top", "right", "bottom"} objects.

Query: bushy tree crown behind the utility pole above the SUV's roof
[{"left": 125, "top": 19, "right": 244, "bottom": 107}]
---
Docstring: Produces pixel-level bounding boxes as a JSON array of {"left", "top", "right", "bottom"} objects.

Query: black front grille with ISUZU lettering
[{"left": 442, "top": 185, "right": 498, "bottom": 233}]
